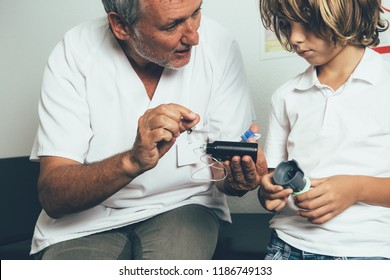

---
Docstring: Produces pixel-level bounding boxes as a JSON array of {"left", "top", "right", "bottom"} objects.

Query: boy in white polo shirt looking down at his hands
[{"left": 259, "top": 0, "right": 390, "bottom": 259}]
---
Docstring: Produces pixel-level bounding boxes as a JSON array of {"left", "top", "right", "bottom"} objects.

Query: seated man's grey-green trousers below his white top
[{"left": 35, "top": 205, "right": 220, "bottom": 260}]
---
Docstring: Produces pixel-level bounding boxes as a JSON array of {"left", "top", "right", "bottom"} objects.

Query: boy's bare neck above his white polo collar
[{"left": 316, "top": 45, "right": 365, "bottom": 90}]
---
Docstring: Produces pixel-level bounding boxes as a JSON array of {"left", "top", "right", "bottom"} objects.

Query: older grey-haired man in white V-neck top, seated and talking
[{"left": 31, "top": 0, "right": 265, "bottom": 259}]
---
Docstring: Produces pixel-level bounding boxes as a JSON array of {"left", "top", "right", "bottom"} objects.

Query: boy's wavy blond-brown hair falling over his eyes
[{"left": 259, "top": 0, "right": 389, "bottom": 51}]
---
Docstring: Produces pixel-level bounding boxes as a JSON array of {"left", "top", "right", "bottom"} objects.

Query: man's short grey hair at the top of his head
[{"left": 102, "top": 0, "right": 142, "bottom": 28}]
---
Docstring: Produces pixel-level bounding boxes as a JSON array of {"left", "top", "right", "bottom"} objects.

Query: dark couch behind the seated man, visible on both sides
[{"left": 0, "top": 157, "right": 272, "bottom": 260}]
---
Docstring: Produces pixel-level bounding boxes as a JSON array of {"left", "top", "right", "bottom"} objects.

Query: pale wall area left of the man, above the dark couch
[{"left": 0, "top": 0, "right": 104, "bottom": 158}]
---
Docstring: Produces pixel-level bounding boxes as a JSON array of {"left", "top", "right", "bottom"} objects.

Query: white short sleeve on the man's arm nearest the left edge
[{"left": 30, "top": 37, "right": 92, "bottom": 163}]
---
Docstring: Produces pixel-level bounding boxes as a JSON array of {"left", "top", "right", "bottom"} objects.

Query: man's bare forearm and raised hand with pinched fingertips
[{"left": 38, "top": 104, "right": 199, "bottom": 218}]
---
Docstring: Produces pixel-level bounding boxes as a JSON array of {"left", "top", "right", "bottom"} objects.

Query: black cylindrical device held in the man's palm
[{"left": 206, "top": 141, "right": 258, "bottom": 162}]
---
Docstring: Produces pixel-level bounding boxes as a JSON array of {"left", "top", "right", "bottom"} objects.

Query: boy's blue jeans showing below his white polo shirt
[{"left": 265, "top": 230, "right": 387, "bottom": 260}]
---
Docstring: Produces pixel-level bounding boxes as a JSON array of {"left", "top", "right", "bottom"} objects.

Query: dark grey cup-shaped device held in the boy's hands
[{"left": 273, "top": 159, "right": 310, "bottom": 194}]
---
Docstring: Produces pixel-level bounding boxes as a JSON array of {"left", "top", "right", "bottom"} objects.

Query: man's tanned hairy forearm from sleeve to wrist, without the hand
[{"left": 38, "top": 153, "right": 139, "bottom": 218}]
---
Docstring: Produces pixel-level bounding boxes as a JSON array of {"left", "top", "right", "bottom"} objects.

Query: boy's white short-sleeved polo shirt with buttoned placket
[{"left": 265, "top": 49, "right": 390, "bottom": 257}]
